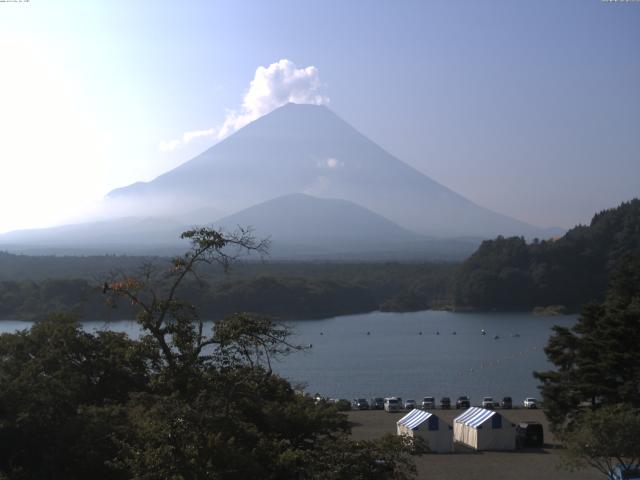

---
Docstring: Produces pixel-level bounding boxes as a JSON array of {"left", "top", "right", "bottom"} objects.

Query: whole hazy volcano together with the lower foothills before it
[{"left": 0, "top": 104, "right": 559, "bottom": 257}]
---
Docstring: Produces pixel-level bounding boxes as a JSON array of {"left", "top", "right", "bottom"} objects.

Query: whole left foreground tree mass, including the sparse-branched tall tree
[{"left": 0, "top": 230, "right": 415, "bottom": 480}]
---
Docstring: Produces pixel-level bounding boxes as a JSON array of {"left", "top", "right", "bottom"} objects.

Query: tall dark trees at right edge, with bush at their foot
[{"left": 534, "top": 217, "right": 640, "bottom": 475}]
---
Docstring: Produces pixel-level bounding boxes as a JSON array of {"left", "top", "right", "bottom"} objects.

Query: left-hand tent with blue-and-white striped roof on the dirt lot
[{"left": 398, "top": 408, "right": 453, "bottom": 452}]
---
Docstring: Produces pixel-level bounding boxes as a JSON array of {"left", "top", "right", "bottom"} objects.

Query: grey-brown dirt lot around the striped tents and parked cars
[{"left": 349, "top": 409, "right": 603, "bottom": 480}]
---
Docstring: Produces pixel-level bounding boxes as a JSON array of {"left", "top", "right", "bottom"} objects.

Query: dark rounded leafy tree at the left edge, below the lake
[{"left": 0, "top": 316, "right": 153, "bottom": 479}]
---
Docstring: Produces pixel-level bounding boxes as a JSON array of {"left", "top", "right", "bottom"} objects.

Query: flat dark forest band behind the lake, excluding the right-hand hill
[{"left": 0, "top": 253, "right": 455, "bottom": 320}]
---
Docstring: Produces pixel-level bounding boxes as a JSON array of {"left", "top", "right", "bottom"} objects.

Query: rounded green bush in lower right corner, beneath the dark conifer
[{"left": 562, "top": 405, "right": 640, "bottom": 475}]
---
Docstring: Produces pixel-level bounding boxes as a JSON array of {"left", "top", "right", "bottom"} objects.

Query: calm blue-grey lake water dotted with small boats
[{"left": 0, "top": 311, "right": 576, "bottom": 403}]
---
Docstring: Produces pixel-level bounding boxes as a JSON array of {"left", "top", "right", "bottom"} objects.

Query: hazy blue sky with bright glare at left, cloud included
[{"left": 0, "top": 0, "right": 640, "bottom": 231}]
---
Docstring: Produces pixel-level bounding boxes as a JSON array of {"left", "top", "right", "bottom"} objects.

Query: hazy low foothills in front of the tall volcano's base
[{"left": 0, "top": 194, "right": 480, "bottom": 260}]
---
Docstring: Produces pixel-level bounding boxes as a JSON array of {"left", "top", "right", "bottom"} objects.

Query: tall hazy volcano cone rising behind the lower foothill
[{"left": 109, "top": 104, "right": 547, "bottom": 237}]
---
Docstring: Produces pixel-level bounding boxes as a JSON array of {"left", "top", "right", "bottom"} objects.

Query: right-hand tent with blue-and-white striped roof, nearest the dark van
[{"left": 453, "top": 407, "right": 516, "bottom": 450}]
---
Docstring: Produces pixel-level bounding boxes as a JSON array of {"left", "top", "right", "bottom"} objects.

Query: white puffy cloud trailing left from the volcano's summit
[{"left": 158, "top": 58, "right": 329, "bottom": 152}]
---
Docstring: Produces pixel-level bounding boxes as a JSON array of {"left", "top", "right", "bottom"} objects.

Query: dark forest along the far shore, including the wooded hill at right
[{"left": 0, "top": 199, "right": 640, "bottom": 320}]
